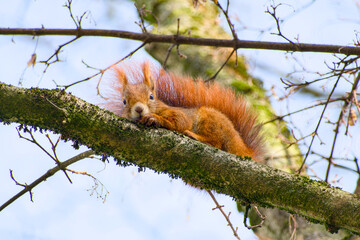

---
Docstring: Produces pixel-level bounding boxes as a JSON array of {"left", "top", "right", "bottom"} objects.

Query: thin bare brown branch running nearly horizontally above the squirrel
[{"left": 0, "top": 28, "right": 360, "bottom": 56}]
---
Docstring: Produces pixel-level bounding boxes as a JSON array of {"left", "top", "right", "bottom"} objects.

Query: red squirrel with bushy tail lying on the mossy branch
[{"left": 105, "top": 62, "right": 263, "bottom": 161}]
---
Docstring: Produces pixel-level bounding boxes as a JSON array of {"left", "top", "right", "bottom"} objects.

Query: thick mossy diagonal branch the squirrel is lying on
[{"left": 0, "top": 83, "right": 360, "bottom": 234}]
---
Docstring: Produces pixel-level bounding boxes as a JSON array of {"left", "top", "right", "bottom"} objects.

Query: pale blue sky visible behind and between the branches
[{"left": 0, "top": 0, "right": 360, "bottom": 240}]
